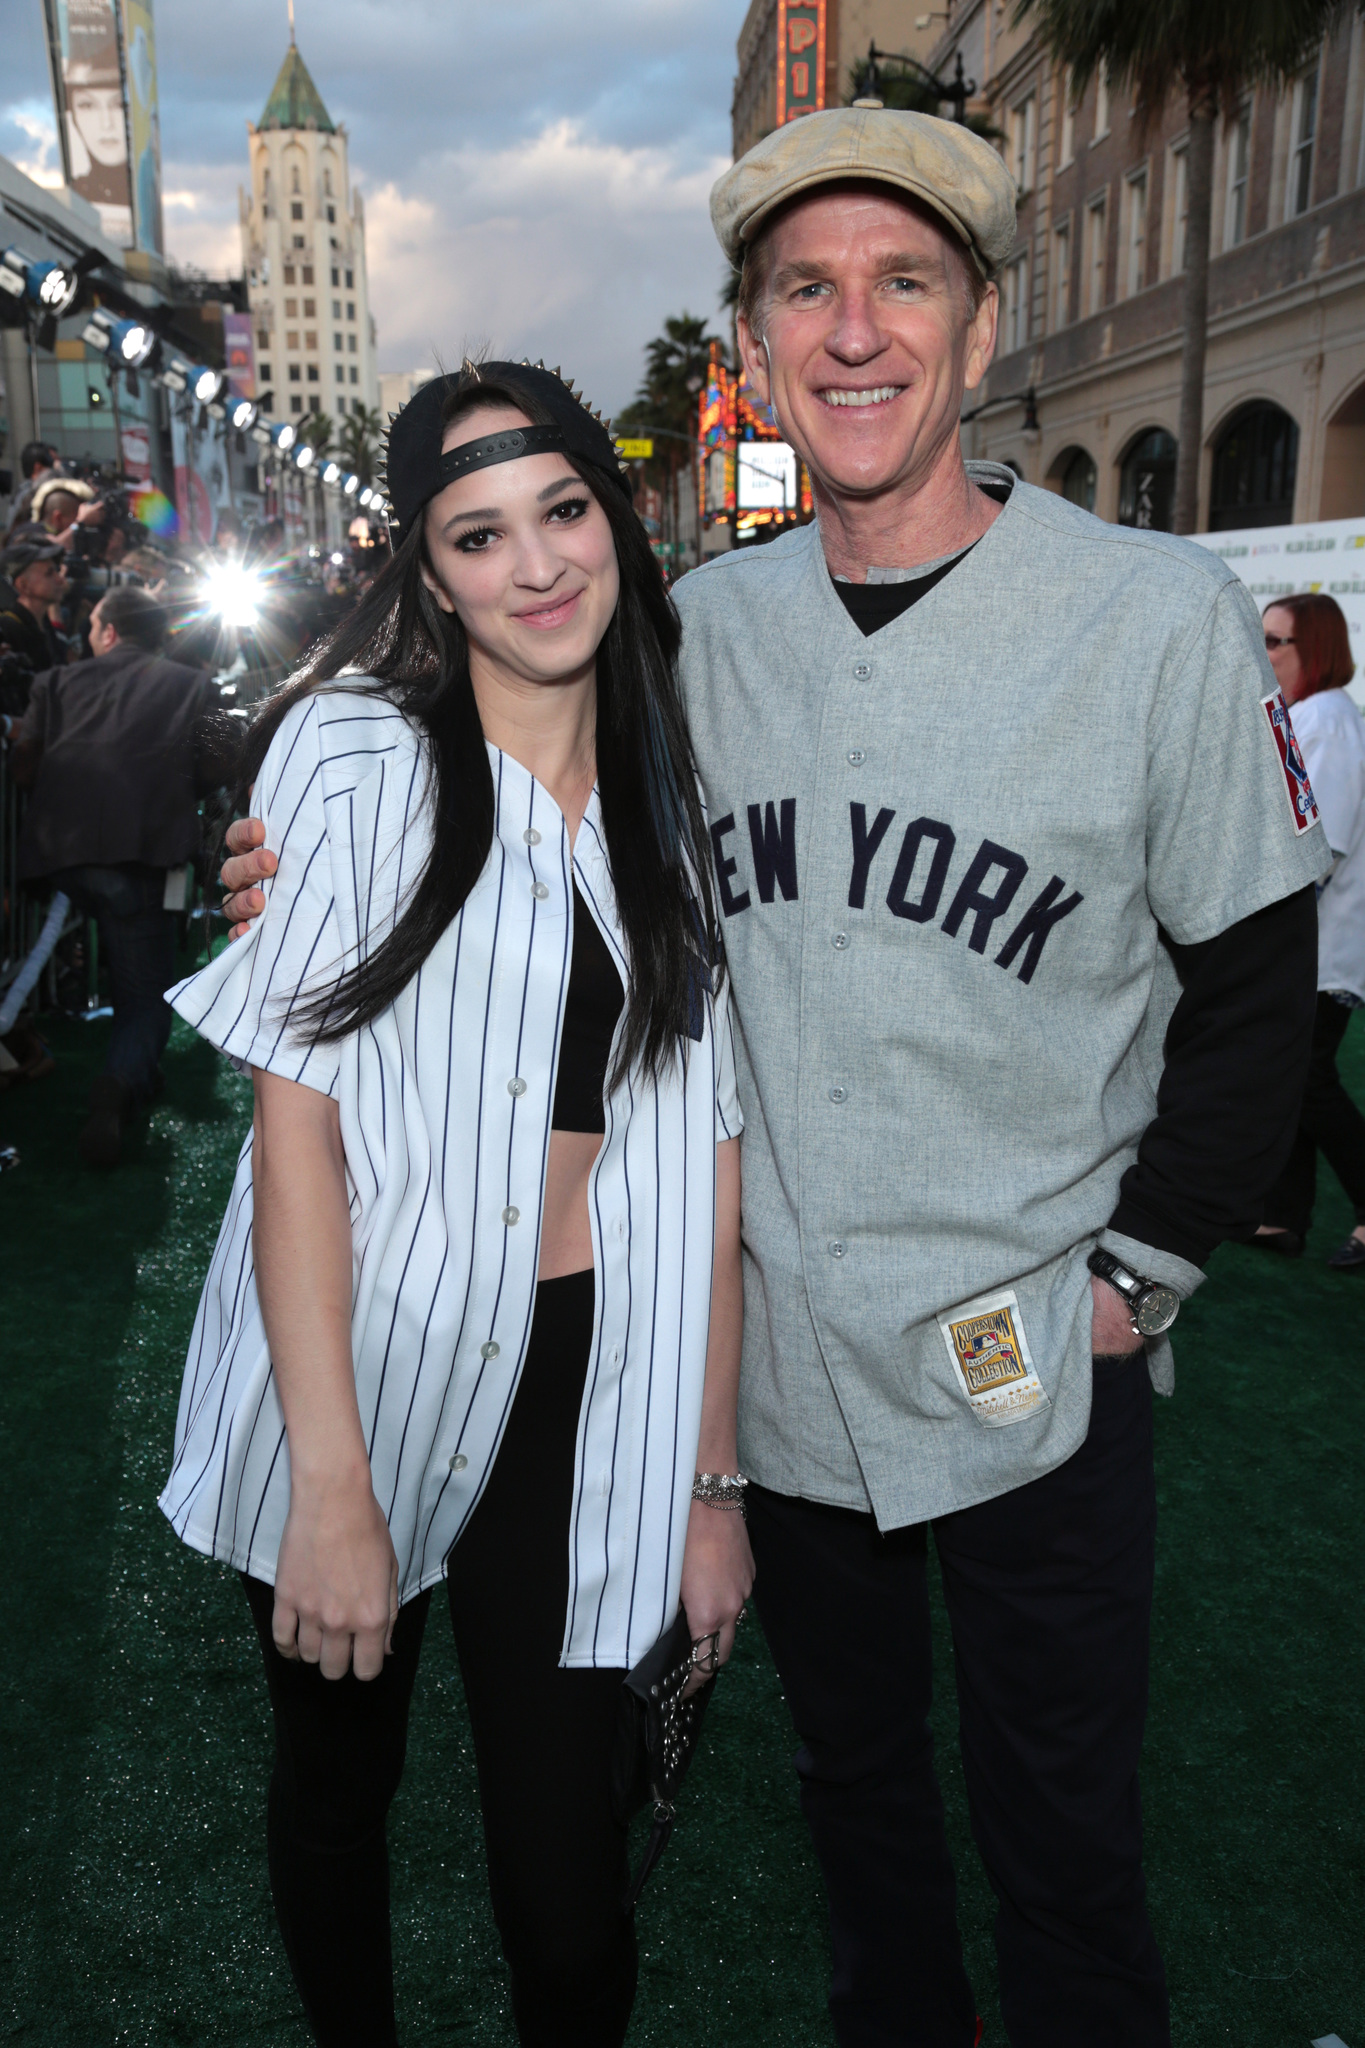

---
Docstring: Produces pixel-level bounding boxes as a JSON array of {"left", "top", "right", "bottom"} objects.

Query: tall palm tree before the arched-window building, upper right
[{"left": 1015, "top": 0, "right": 1340, "bottom": 532}]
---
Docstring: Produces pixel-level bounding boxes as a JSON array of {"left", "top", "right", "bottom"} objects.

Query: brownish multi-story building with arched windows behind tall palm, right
[{"left": 933, "top": 0, "right": 1365, "bottom": 530}]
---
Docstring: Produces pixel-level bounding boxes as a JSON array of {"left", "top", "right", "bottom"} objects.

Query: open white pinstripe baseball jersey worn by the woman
[{"left": 162, "top": 690, "right": 741, "bottom": 1665}]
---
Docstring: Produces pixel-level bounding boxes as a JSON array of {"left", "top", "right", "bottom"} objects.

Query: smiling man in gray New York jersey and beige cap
[{"left": 225, "top": 109, "right": 1328, "bottom": 2048}]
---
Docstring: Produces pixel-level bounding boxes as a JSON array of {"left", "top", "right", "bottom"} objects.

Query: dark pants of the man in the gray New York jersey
[{"left": 749, "top": 1354, "right": 1171, "bottom": 2048}]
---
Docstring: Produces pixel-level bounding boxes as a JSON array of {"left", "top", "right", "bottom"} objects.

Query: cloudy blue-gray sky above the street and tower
[{"left": 0, "top": 0, "right": 745, "bottom": 412}]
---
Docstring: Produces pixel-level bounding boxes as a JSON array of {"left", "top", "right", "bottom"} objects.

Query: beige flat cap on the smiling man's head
[{"left": 710, "top": 106, "right": 1015, "bottom": 274}]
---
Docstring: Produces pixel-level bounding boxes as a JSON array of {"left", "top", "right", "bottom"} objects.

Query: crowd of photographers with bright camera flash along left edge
[{"left": 0, "top": 442, "right": 387, "bottom": 1165}]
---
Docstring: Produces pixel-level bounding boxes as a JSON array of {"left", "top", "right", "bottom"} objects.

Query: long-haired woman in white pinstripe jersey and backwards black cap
[{"left": 162, "top": 365, "right": 753, "bottom": 2048}]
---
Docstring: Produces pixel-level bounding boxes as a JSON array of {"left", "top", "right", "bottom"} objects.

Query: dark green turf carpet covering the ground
[{"left": 0, "top": 1020, "right": 1365, "bottom": 2048}]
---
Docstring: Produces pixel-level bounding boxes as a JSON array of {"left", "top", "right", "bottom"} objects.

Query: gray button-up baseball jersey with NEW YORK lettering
[{"left": 677, "top": 463, "right": 1330, "bottom": 1528}]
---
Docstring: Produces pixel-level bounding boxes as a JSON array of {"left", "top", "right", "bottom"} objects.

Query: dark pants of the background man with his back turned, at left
[{"left": 47, "top": 860, "right": 176, "bottom": 1102}]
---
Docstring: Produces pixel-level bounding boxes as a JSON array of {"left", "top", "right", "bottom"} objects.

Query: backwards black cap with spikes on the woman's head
[{"left": 383, "top": 362, "right": 632, "bottom": 532}]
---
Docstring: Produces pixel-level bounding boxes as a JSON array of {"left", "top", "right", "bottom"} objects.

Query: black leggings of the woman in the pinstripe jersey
[{"left": 246, "top": 1272, "right": 636, "bottom": 2048}]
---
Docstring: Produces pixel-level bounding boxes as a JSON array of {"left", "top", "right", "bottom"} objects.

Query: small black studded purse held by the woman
[{"left": 612, "top": 1608, "right": 714, "bottom": 1913}]
